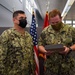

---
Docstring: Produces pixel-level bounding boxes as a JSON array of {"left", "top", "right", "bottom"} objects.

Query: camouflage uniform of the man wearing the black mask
[{"left": 0, "top": 28, "right": 33, "bottom": 75}]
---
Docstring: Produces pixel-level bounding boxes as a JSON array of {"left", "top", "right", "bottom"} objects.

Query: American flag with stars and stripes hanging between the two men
[{"left": 30, "top": 12, "right": 39, "bottom": 75}]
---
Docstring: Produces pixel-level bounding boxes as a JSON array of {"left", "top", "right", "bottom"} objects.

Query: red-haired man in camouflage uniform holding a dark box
[{"left": 38, "top": 9, "right": 75, "bottom": 75}]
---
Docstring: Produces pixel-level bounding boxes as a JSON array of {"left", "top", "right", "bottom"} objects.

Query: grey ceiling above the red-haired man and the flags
[{"left": 35, "top": 0, "right": 75, "bottom": 20}]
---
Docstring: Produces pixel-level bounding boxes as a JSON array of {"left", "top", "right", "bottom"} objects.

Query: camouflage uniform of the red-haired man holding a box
[{"left": 38, "top": 23, "right": 75, "bottom": 75}]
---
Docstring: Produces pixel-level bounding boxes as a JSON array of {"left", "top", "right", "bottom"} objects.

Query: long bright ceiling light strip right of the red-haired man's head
[{"left": 61, "top": 0, "right": 75, "bottom": 19}]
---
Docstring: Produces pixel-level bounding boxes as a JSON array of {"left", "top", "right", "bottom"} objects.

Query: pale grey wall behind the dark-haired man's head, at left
[{"left": 0, "top": 0, "right": 23, "bottom": 27}]
